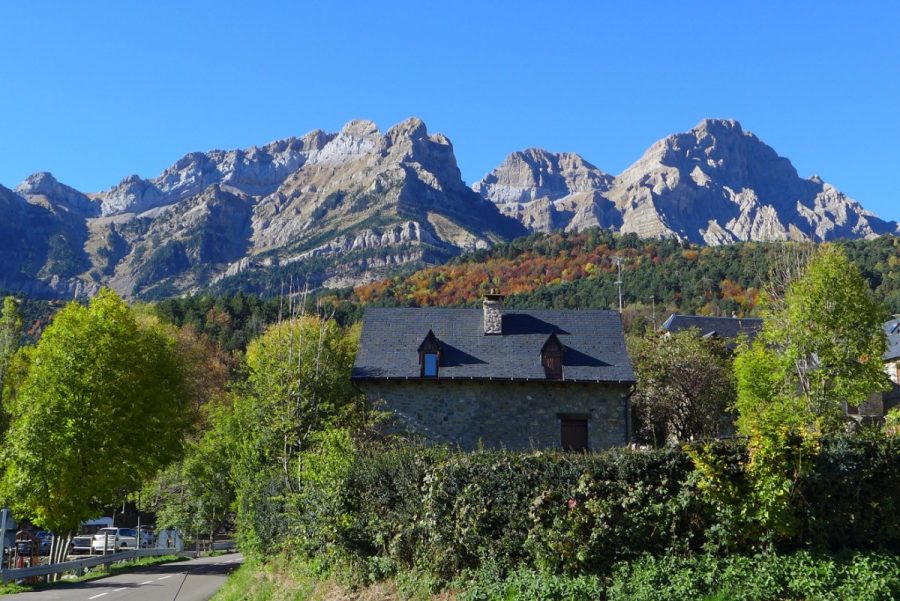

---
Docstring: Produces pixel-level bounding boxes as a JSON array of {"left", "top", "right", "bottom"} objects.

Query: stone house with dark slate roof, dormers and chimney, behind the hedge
[{"left": 352, "top": 293, "right": 635, "bottom": 450}]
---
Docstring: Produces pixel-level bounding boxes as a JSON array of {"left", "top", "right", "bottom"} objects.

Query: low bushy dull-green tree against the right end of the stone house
[{"left": 628, "top": 330, "right": 735, "bottom": 445}]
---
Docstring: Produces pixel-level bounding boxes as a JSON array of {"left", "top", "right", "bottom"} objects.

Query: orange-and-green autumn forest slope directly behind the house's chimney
[{"left": 353, "top": 229, "right": 900, "bottom": 315}]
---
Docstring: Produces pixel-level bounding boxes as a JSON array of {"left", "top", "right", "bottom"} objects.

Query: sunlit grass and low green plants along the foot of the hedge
[{"left": 206, "top": 551, "right": 900, "bottom": 601}]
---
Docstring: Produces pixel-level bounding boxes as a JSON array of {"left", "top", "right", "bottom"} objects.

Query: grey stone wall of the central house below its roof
[{"left": 358, "top": 380, "right": 630, "bottom": 450}]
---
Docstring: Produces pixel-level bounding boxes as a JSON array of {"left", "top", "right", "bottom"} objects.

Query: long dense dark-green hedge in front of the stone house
[{"left": 291, "top": 435, "right": 900, "bottom": 580}]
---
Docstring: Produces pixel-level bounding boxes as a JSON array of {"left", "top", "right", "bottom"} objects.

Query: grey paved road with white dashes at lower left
[{"left": 10, "top": 553, "right": 243, "bottom": 601}]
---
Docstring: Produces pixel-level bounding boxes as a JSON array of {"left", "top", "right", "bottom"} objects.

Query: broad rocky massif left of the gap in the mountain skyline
[{"left": 0, "top": 118, "right": 525, "bottom": 298}]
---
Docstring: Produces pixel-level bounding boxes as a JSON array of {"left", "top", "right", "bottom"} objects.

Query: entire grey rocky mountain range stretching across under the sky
[{"left": 0, "top": 118, "right": 900, "bottom": 298}]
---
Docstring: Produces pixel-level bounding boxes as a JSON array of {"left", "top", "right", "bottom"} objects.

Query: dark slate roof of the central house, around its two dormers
[{"left": 351, "top": 308, "right": 635, "bottom": 383}]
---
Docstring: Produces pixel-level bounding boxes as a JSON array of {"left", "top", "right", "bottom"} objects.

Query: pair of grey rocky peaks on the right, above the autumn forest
[{"left": 475, "top": 119, "right": 898, "bottom": 244}]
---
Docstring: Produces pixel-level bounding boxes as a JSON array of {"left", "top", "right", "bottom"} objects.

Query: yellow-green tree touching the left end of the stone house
[{"left": 232, "top": 311, "right": 366, "bottom": 552}]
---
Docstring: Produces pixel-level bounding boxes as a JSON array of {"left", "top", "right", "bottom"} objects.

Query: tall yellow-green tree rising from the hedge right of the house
[{"left": 689, "top": 244, "right": 887, "bottom": 545}]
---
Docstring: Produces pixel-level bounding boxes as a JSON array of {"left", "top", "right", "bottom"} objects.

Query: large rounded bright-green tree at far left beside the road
[{"left": 0, "top": 290, "right": 190, "bottom": 556}]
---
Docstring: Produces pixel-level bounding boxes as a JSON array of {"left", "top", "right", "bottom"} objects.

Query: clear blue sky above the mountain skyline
[{"left": 0, "top": 0, "right": 900, "bottom": 220}]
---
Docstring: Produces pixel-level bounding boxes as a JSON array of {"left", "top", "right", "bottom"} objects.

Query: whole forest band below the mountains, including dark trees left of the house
[{"left": 146, "top": 229, "right": 900, "bottom": 350}]
